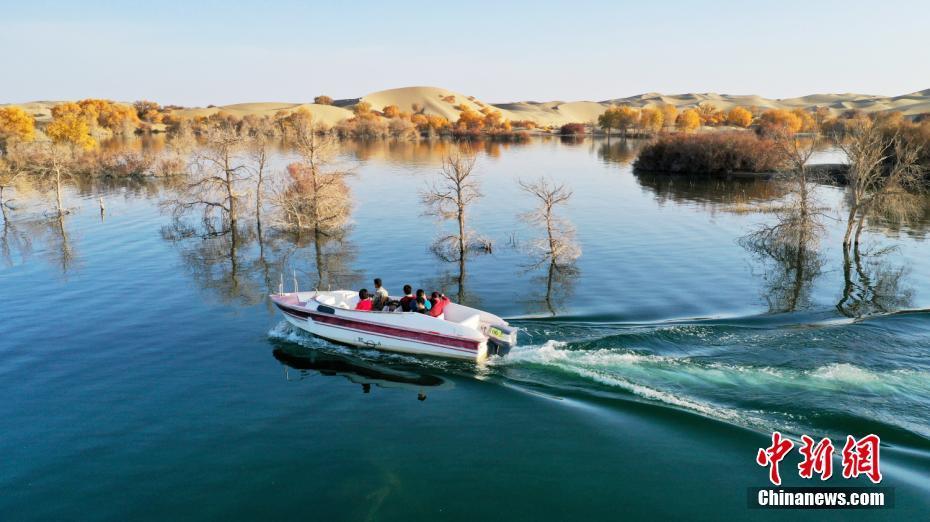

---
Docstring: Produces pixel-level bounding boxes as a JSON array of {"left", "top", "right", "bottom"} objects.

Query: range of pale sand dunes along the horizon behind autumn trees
[{"left": 7, "top": 87, "right": 930, "bottom": 126}]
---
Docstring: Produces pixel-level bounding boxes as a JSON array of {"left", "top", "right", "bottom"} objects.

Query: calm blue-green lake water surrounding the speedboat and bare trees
[{"left": 0, "top": 136, "right": 930, "bottom": 520}]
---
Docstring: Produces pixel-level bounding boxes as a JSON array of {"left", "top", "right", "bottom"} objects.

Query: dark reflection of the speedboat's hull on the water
[{"left": 272, "top": 345, "right": 452, "bottom": 401}]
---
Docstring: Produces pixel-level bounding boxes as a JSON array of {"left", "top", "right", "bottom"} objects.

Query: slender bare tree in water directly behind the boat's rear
[{"left": 420, "top": 148, "right": 482, "bottom": 301}]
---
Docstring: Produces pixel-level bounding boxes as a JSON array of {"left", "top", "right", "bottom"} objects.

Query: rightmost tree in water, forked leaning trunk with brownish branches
[{"left": 837, "top": 119, "right": 923, "bottom": 249}]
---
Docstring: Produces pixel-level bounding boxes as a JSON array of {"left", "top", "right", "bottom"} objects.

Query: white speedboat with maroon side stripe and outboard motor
[{"left": 270, "top": 290, "right": 517, "bottom": 362}]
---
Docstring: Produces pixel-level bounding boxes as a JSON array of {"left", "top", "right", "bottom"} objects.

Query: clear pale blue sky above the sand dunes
[{"left": 0, "top": 0, "right": 930, "bottom": 105}]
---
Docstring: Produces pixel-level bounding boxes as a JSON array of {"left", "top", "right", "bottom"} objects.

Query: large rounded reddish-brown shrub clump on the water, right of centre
[{"left": 633, "top": 132, "right": 781, "bottom": 174}]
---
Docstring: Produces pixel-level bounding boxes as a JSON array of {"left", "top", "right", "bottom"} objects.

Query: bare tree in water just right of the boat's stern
[{"left": 519, "top": 178, "right": 581, "bottom": 314}]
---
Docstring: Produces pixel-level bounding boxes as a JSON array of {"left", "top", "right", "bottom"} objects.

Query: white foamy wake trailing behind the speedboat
[{"left": 271, "top": 311, "right": 930, "bottom": 448}]
